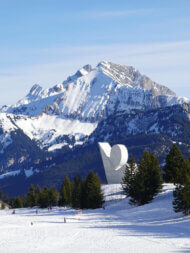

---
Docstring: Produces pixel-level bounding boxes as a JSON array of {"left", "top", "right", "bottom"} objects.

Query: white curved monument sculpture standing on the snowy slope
[{"left": 98, "top": 142, "right": 128, "bottom": 184}]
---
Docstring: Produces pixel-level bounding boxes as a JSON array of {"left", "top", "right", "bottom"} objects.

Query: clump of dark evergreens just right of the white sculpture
[{"left": 123, "top": 151, "right": 162, "bottom": 205}]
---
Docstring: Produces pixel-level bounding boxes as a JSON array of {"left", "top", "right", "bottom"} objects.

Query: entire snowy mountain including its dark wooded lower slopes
[{"left": 0, "top": 61, "right": 190, "bottom": 194}]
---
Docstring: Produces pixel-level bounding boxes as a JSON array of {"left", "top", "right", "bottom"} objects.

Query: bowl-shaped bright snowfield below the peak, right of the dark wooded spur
[{"left": 15, "top": 114, "right": 97, "bottom": 151}]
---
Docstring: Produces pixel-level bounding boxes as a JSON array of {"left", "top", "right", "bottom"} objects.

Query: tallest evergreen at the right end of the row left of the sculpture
[{"left": 85, "top": 171, "right": 104, "bottom": 209}]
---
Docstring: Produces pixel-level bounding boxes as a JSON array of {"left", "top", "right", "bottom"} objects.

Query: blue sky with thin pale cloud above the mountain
[{"left": 0, "top": 0, "right": 190, "bottom": 105}]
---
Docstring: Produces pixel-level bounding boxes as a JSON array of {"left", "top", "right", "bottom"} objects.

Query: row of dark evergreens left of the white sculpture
[{"left": 11, "top": 171, "right": 104, "bottom": 209}]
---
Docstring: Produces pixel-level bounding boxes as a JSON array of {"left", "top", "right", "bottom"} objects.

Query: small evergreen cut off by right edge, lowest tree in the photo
[{"left": 173, "top": 181, "right": 190, "bottom": 215}]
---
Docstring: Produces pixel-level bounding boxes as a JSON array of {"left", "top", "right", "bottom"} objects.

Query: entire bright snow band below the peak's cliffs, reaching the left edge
[{"left": 0, "top": 113, "right": 97, "bottom": 151}]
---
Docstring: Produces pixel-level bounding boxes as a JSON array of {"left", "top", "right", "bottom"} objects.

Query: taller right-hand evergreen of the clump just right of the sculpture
[{"left": 130, "top": 151, "right": 162, "bottom": 205}]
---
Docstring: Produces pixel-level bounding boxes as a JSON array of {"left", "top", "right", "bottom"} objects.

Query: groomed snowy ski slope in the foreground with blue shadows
[{"left": 0, "top": 184, "right": 190, "bottom": 253}]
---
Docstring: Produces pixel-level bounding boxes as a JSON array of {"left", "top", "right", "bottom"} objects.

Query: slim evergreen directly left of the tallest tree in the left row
[{"left": 72, "top": 176, "right": 82, "bottom": 208}]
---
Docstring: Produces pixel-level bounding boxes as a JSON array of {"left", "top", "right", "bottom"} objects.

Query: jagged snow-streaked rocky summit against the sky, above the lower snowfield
[{"left": 1, "top": 61, "right": 189, "bottom": 122}]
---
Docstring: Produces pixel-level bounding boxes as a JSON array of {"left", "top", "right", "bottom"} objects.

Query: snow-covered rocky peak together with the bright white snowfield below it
[{"left": 1, "top": 61, "right": 189, "bottom": 151}]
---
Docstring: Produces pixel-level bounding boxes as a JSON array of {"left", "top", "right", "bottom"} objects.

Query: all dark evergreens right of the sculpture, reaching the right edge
[{"left": 123, "top": 144, "right": 190, "bottom": 215}]
